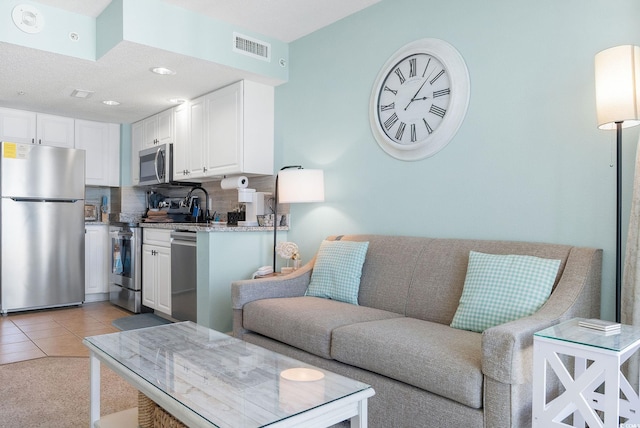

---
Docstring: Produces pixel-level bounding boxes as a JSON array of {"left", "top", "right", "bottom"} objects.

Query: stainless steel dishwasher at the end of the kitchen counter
[{"left": 171, "top": 231, "right": 198, "bottom": 322}]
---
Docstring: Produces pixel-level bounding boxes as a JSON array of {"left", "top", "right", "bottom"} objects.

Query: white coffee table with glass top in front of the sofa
[{"left": 84, "top": 322, "right": 375, "bottom": 428}]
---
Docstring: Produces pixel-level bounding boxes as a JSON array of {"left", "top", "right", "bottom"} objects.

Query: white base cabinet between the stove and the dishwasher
[{"left": 142, "top": 228, "right": 171, "bottom": 316}]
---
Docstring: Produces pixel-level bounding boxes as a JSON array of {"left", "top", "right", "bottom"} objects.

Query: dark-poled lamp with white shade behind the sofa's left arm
[{"left": 273, "top": 165, "right": 324, "bottom": 272}]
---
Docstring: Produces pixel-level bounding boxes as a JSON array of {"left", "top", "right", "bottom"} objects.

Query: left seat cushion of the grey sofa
[{"left": 243, "top": 297, "right": 402, "bottom": 358}]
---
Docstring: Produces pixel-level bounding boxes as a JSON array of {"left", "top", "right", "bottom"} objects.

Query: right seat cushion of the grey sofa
[{"left": 331, "top": 317, "right": 483, "bottom": 409}]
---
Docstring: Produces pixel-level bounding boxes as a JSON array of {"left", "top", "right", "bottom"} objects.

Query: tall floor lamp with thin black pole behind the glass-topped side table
[{"left": 595, "top": 45, "right": 640, "bottom": 322}]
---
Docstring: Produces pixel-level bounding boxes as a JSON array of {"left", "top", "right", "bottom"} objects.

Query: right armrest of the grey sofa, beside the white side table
[{"left": 482, "top": 247, "right": 602, "bottom": 384}]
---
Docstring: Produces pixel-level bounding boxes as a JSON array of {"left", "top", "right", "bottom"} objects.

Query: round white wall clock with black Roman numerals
[{"left": 369, "top": 39, "right": 470, "bottom": 161}]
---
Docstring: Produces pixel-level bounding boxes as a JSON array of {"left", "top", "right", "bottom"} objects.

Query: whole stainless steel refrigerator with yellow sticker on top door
[{"left": 0, "top": 142, "right": 85, "bottom": 314}]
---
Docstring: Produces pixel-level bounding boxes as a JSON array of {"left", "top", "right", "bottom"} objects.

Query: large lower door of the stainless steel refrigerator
[{"left": 0, "top": 198, "right": 85, "bottom": 313}]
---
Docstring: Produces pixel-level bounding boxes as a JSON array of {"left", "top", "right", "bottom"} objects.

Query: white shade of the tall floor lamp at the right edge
[{"left": 595, "top": 45, "right": 640, "bottom": 129}]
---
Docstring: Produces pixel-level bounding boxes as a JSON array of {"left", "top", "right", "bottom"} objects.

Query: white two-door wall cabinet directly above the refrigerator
[{"left": 0, "top": 108, "right": 74, "bottom": 148}]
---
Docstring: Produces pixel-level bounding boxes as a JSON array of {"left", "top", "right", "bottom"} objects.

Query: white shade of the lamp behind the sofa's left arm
[{"left": 278, "top": 169, "right": 324, "bottom": 204}]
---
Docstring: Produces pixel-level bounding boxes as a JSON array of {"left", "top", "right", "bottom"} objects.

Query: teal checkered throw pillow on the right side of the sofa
[{"left": 451, "top": 251, "right": 560, "bottom": 333}]
